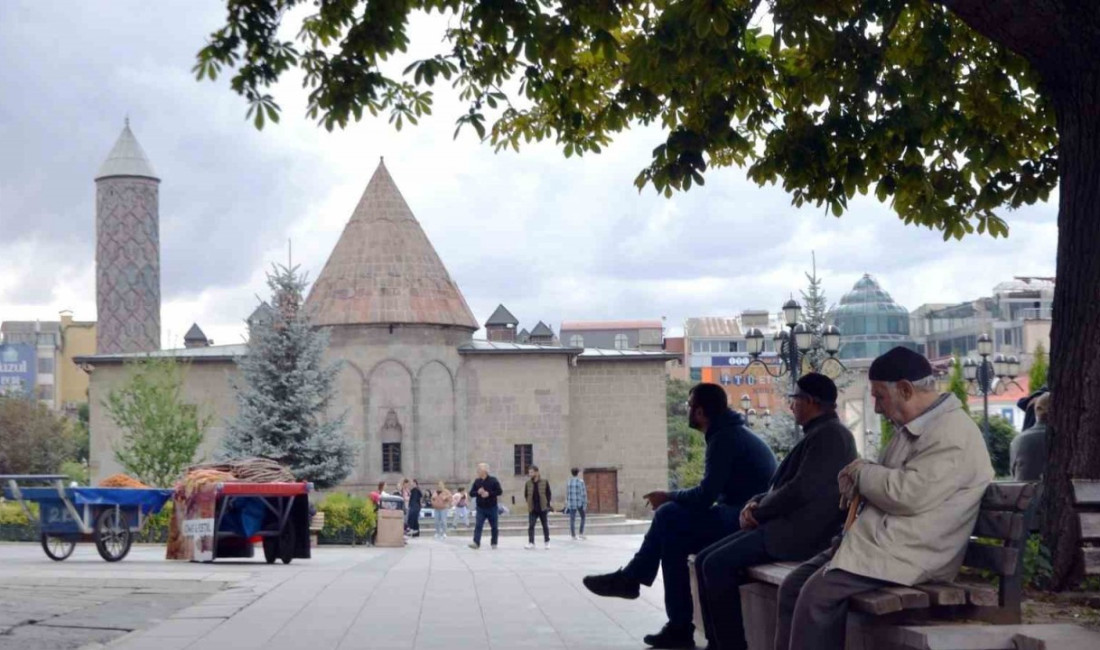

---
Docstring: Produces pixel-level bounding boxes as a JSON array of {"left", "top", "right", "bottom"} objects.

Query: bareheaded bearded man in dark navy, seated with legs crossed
[{"left": 584, "top": 384, "right": 776, "bottom": 648}]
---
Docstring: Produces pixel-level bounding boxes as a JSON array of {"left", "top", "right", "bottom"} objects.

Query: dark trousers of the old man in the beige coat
[{"left": 776, "top": 549, "right": 892, "bottom": 650}]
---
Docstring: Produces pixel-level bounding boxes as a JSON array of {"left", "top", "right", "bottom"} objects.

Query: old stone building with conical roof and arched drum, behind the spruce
[{"left": 83, "top": 164, "right": 672, "bottom": 513}]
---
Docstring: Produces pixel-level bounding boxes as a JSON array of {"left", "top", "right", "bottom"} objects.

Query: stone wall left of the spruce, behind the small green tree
[{"left": 88, "top": 361, "right": 237, "bottom": 487}]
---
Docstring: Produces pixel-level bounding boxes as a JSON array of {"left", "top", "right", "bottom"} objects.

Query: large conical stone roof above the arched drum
[{"left": 306, "top": 163, "right": 479, "bottom": 331}]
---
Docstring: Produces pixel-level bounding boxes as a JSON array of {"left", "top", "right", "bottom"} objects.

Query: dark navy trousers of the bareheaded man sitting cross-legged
[{"left": 623, "top": 502, "right": 740, "bottom": 628}]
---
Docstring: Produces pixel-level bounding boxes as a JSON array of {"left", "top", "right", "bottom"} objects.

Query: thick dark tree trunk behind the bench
[{"left": 1042, "top": 60, "right": 1100, "bottom": 590}]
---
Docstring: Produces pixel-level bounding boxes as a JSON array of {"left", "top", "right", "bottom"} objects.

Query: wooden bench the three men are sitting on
[{"left": 689, "top": 482, "right": 1034, "bottom": 650}]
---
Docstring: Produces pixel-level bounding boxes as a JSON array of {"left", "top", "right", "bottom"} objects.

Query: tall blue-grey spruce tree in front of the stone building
[{"left": 222, "top": 265, "right": 354, "bottom": 488}]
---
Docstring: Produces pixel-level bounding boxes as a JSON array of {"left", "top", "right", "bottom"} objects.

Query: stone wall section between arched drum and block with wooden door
[{"left": 459, "top": 354, "right": 570, "bottom": 513}]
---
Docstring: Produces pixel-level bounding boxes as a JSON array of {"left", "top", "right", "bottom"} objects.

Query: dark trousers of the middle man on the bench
[{"left": 695, "top": 529, "right": 774, "bottom": 650}]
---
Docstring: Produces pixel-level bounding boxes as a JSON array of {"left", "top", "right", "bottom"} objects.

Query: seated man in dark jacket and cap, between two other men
[{"left": 695, "top": 373, "right": 858, "bottom": 650}]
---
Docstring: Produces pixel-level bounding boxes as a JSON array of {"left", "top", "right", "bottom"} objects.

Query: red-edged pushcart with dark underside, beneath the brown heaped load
[{"left": 183, "top": 483, "right": 314, "bottom": 564}]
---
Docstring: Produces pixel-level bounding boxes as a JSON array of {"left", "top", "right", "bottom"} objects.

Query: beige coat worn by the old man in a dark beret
[{"left": 829, "top": 395, "right": 993, "bottom": 585}]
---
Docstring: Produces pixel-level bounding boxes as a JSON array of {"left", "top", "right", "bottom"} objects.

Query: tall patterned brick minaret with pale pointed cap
[{"left": 96, "top": 119, "right": 161, "bottom": 354}]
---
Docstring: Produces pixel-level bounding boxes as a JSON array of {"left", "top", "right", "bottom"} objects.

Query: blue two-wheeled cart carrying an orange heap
[{"left": 0, "top": 474, "right": 172, "bottom": 562}]
